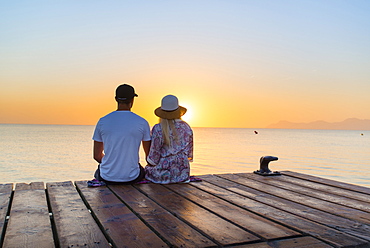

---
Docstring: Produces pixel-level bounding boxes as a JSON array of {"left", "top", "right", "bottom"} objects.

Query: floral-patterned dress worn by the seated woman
[{"left": 145, "top": 119, "right": 193, "bottom": 184}]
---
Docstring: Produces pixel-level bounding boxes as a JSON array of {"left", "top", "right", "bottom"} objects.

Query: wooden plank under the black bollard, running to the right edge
[{"left": 240, "top": 173, "right": 370, "bottom": 212}]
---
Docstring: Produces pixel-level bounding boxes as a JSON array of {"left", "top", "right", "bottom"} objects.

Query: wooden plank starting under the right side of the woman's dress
[{"left": 166, "top": 184, "right": 301, "bottom": 240}]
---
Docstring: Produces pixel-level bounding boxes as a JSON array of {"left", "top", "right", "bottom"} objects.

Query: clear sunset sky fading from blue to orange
[{"left": 0, "top": 0, "right": 370, "bottom": 128}]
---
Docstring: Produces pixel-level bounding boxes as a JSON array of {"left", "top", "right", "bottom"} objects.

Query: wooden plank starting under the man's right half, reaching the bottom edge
[{"left": 109, "top": 185, "right": 216, "bottom": 247}]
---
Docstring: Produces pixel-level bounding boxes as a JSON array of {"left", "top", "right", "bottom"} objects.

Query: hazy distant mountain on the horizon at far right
[{"left": 267, "top": 118, "right": 370, "bottom": 130}]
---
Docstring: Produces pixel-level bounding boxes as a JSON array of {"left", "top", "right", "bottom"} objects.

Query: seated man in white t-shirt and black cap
[{"left": 93, "top": 84, "right": 150, "bottom": 184}]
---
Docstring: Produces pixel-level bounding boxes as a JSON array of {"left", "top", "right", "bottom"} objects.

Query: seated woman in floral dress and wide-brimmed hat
[{"left": 145, "top": 95, "right": 193, "bottom": 184}]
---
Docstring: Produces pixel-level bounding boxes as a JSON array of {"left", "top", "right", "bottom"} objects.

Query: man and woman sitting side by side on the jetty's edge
[{"left": 88, "top": 84, "right": 193, "bottom": 186}]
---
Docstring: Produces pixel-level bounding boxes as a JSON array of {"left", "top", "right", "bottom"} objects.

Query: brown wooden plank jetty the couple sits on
[{"left": 0, "top": 171, "right": 370, "bottom": 248}]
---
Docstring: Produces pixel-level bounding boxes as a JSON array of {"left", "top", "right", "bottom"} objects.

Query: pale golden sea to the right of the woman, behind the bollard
[{"left": 192, "top": 128, "right": 370, "bottom": 186}]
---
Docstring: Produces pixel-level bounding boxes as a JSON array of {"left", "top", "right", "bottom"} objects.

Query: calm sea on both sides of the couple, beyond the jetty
[{"left": 0, "top": 124, "right": 370, "bottom": 187}]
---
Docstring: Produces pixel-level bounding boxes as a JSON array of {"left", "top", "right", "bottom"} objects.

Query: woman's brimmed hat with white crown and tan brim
[{"left": 154, "top": 95, "right": 187, "bottom": 120}]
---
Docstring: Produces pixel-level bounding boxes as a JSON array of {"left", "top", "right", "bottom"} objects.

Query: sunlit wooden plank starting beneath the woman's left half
[{"left": 135, "top": 184, "right": 260, "bottom": 245}]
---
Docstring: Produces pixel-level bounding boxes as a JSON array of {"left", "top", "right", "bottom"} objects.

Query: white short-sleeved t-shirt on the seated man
[{"left": 93, "top": 111, "right": 150, "bottom": 182}]
